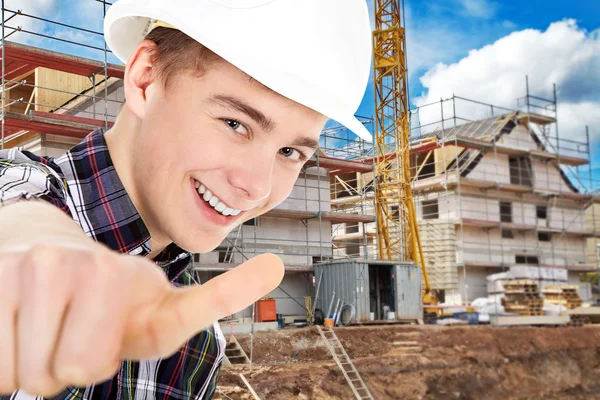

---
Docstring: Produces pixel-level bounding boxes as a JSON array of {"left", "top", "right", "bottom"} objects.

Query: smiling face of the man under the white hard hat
[{"left": 131, "top": 49, "right": 327, "bottom": 252}]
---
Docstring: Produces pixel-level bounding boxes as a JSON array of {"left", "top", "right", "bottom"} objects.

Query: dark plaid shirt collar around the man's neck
[{"left": 56, "top": 128, "right": 191, "bottom": 281}]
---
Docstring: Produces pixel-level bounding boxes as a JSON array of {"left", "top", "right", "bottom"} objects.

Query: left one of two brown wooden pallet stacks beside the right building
[{"left": 502, "top": 280, "right": 544, "bottom": 316}]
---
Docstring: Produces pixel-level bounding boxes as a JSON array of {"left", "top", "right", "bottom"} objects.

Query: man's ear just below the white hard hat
[{"left": 123, "top": 40, "right": 156, "bottom": 119}]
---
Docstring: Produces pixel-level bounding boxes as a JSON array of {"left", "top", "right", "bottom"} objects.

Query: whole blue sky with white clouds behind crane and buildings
[{"left": 5, "top": 0, "right": 600, "bottom": 186}]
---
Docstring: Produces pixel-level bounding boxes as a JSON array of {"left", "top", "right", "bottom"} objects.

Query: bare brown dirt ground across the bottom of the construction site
[{"left": 215, "top": 325, "right": 600, "bottom": 400}]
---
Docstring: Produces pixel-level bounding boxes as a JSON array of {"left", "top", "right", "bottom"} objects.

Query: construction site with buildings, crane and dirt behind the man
[{"left": 0, "top": 0, "right": 600, "bottom": 399}]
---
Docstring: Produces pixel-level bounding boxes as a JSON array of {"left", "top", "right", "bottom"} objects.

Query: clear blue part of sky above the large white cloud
[{"left": 358, "top": 0, "right": 600, "bottom": 115}]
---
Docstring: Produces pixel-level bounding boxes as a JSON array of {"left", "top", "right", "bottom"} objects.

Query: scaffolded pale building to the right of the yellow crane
[{"left": 411, "top": 84, "right": 600, "bottom": 303}]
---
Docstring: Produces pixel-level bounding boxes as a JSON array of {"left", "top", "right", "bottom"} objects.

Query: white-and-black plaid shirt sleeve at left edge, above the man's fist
[{"left": 0, "top": 149, "right": 68, "bottom": 213}]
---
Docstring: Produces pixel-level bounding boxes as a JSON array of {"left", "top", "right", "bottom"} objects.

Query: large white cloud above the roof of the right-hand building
[{"left": 413, "top": 20, "right": 600, "bottom": 144}]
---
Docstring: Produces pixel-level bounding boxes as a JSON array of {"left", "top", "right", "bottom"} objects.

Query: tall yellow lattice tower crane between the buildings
[{"left": 373, "top": 0, "right": 437, "bottom": 304}]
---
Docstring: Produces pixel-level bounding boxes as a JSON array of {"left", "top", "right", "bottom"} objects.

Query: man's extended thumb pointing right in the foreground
[{"left": 122, "top": 254, "right": 284, "bottom": 359}]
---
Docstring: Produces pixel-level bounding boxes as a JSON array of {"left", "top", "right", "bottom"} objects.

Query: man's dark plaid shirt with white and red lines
[{"left": 0, "top": 129, "right": 225, "bottom": 400}]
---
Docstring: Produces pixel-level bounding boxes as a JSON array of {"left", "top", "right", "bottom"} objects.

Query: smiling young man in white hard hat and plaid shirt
[{"left": 0, "top": 0, "right": 371, "bottom": 399}]
